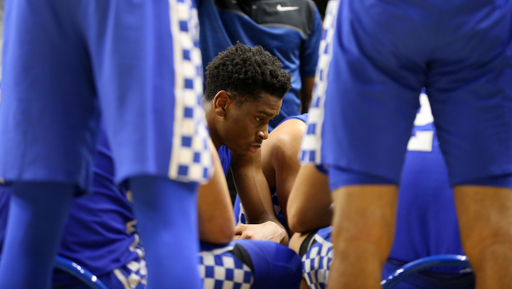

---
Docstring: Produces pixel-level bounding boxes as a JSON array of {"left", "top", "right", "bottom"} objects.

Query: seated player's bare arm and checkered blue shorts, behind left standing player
[{"left": 198, "top": 140, "right": 302, "bottom": 289}]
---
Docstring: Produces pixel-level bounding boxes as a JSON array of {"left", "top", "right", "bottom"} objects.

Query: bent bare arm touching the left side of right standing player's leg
[{"left": 288, "top": 164, "right": 332, "bottom": 233}]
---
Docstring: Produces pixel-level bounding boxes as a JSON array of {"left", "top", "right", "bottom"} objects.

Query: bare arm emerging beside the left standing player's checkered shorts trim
[{"left": 198, "top": 143, "right": 235, "bottom": 244}]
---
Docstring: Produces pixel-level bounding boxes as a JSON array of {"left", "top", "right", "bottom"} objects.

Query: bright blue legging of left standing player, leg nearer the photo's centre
[{"left": 129, "top": 176, "right": 201, "bottom": 289}]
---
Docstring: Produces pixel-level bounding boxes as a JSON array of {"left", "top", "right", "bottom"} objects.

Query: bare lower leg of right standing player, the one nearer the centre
[{"left": 328, "top": 185, "right": 398, "bottom": 288}]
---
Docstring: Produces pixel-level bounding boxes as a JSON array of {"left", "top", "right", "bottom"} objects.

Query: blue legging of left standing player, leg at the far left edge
[{"left": 0, "top": 182, "right": 74, "bottom": 289}]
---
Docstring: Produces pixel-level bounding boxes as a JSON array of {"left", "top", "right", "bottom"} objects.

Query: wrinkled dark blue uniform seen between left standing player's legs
[{"left": 0, "top": 129, "right": 147, "bottom": 289}]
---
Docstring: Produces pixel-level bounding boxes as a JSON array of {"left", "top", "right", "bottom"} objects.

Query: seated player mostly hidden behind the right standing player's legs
[{"left": 288, "top": 95, "right": 474, "bottom": 289}]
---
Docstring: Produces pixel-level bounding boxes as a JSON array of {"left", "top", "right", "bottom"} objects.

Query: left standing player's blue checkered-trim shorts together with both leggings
[{"left": 0, "top": 0, "right": 213, "bottom": 289}]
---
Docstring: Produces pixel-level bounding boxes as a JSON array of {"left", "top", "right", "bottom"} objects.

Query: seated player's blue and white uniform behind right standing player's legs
[{"left": 302, "top": 95, "right": 474, "bottom": 289}]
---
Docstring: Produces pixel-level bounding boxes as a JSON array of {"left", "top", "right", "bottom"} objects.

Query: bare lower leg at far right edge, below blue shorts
[{"left": 453, "top": 186, "right": 512, "bottom": 289}]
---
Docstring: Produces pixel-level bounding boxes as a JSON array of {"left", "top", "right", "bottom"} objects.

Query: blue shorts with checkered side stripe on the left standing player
[{"left": 0, "top": 0, "right": 212, "bottom": 191}]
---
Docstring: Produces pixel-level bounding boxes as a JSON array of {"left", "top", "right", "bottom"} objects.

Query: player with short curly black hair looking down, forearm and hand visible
[{"left": 204, "top": 43, "right": 290, "bottom": 245}]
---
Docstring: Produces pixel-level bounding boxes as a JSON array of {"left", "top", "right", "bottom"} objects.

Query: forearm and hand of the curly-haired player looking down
[{"left": 231, "top": 150, "right": 288, "bottom": 244}]
